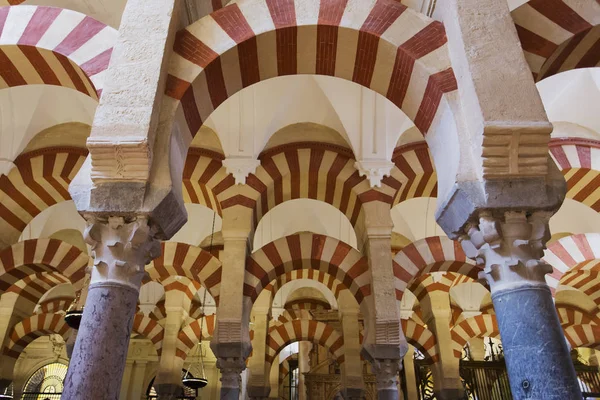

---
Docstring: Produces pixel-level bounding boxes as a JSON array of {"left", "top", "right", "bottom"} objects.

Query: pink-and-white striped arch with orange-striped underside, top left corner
[{"left": 0, "top": 6, "right": 118, "bottom": 99}]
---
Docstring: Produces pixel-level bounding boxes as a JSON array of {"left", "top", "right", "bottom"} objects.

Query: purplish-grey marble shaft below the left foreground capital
[{"left": 62, "top": 282, "right": 139, "bottom": 400}]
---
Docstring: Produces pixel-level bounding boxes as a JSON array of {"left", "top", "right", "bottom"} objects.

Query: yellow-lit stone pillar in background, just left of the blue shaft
[{"left": 420, "top": 291, "right": 464, "bottom": 400}]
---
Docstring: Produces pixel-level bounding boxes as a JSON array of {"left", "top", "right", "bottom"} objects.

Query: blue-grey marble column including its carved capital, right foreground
[{"left": 462, "top": 211, "right": 581, "bottom": 400}]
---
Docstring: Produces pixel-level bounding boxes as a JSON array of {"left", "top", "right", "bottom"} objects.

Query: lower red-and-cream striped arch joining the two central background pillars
[{"left": 244, "top": 233, "right": 371, "bottom": 304}]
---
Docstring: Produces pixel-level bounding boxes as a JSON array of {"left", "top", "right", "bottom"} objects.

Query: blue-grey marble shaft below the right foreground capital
[{"left": 492, "top": 285, "right": 581, "bottom": 400}]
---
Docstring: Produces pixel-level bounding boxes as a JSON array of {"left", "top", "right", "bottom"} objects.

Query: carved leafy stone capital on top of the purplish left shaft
[{"left": 84, "top": 215, "right": 160, "bottom": 290}]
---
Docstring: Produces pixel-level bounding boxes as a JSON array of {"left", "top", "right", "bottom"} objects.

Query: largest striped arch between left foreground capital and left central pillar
[{"left": 146, "top": 242, "right": 221, "bottom": 304}]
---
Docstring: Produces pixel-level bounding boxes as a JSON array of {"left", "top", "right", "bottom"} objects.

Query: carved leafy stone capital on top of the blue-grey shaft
[{"left": 461, "top": 211, "right": 552, "bottom": 292}]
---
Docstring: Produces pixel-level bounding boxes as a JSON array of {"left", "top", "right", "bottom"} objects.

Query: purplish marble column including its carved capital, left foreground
[{"left": 63, "top": 216, "right": 160, "bottom": 400}]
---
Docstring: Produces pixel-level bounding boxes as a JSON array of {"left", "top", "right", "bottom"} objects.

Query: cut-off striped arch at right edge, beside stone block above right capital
[{"left": 550, "top": 138, "right": 600, "bottom": 212}]
